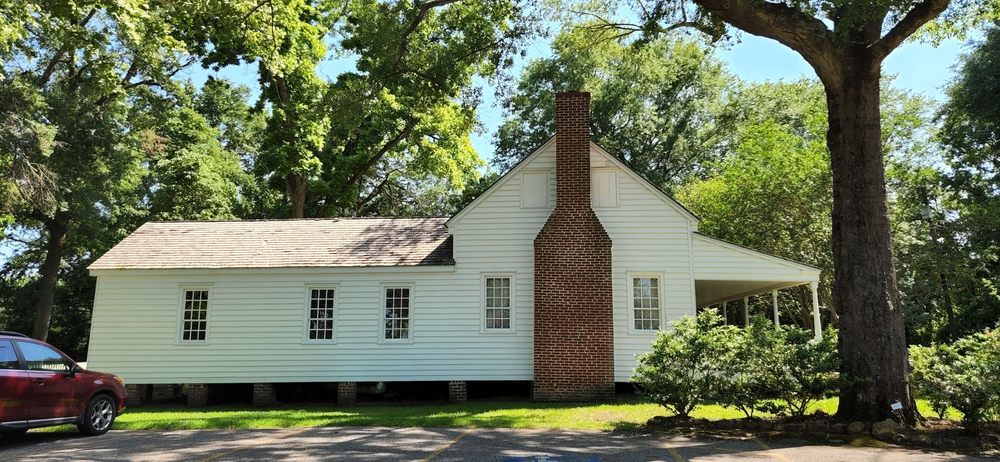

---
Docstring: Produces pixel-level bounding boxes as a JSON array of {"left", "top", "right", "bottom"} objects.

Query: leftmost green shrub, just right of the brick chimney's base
[{"left": 632, "top": 310, "right": 737, "bottom": 417}]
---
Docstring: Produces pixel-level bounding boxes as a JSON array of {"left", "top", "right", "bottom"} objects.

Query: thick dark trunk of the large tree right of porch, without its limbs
[{"left": 824, "top": 58, "right": 917, "bottom": 424}]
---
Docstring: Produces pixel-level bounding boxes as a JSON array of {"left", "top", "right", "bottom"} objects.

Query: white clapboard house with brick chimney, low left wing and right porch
[{"left": 88, "top": 92, "right": 820, "bottom": 403}]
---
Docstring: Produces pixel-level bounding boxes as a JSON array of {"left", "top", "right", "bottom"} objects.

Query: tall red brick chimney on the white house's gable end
[{"left": 534, "top": 92, "right": 615, "bottom": 401}]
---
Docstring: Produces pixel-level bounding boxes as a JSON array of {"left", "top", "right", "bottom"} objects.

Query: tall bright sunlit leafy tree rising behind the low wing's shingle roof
[{"left": 175, "top": 0, "right": 526, "bottom": 216}]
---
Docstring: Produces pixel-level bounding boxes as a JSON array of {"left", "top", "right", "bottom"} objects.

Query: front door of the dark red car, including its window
[{"left": 15, "top": 340, "right": 83, "bottom": 421}]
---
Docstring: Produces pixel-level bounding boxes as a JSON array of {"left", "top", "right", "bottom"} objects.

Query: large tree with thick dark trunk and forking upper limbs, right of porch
[{"left": 592, "top": 0, "right": 992, "bottom": 422}]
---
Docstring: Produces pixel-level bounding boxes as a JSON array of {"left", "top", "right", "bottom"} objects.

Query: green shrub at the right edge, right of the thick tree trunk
[{"left": 910, "top": 330, "right": 1000, "bottom": 430}]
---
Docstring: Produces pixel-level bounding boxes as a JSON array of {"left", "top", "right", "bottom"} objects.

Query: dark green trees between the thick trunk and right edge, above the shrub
[{"left": 887, "top": 25, "right": 1000, "bottom": 344}]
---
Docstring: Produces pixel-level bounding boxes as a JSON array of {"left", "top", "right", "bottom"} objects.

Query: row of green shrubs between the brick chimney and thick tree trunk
[{"left": 632, "top": 310, "right": 840, "bottom": 417}]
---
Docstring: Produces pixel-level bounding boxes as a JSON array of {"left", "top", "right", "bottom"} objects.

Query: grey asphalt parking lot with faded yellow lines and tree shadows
[{"left": 0, "top": 427, "right": 996, "bottom": 462}]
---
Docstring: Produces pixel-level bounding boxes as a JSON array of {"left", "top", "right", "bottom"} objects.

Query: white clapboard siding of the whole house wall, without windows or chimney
[{"left": 88, "top": 142, "right": 711, "bottom": 383}]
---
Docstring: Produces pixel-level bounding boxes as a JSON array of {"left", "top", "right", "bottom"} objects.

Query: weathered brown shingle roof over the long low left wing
[{"left": 89, "top": 218, "right": 454, "bottom": 270}]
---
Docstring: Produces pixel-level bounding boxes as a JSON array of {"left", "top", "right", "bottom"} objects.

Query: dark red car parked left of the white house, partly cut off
[{"left": 0, "top": 331, "right": 125, "bottom": 435}]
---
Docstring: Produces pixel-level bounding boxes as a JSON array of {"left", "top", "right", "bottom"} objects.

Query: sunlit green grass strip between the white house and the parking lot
[{"left": 41, "top": 398, "right": 957, "bottom": 430}]
